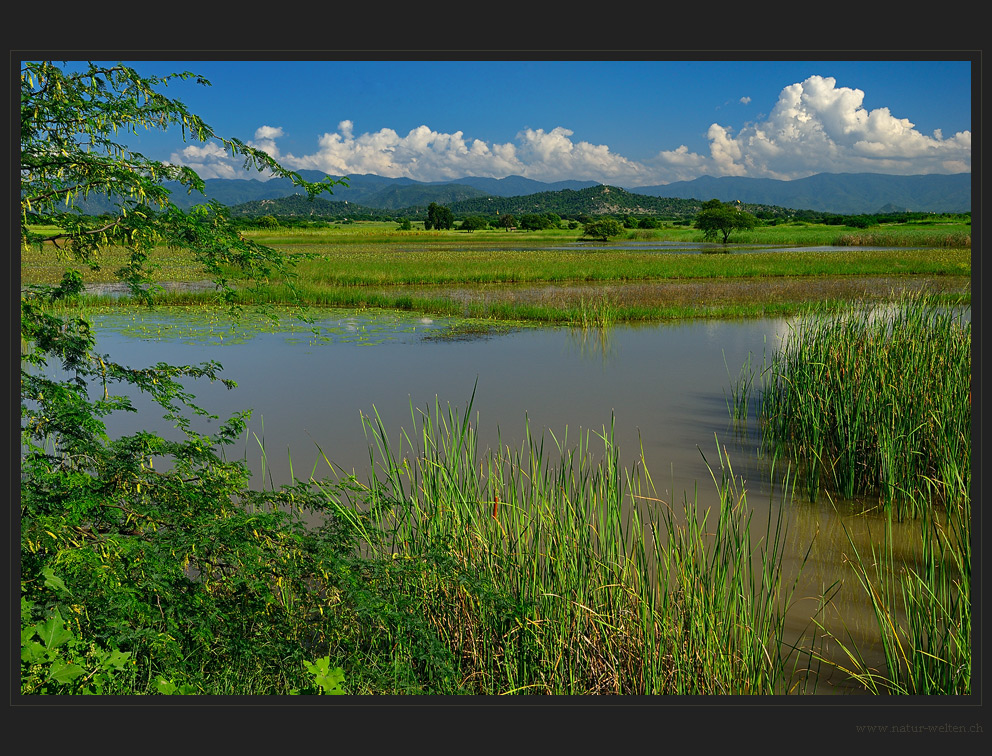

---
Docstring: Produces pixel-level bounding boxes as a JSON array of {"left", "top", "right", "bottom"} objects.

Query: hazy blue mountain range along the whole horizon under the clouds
[{"left": 75, "top": 170, "right": 972, "bottom": 215}]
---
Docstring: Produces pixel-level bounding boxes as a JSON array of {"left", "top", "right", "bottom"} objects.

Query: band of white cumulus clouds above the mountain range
[{"left": 172, "top": 76, "right": 971, "bottom": 186}]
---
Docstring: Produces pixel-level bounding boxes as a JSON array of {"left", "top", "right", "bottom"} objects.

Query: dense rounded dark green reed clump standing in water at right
[{"left": 760, "top": 295, "right": 971, "bottom": 510}]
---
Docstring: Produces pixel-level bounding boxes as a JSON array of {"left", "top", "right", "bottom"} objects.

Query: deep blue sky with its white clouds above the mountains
[{"left": 83, "top": 59, "right": 972, "bottom": 186}]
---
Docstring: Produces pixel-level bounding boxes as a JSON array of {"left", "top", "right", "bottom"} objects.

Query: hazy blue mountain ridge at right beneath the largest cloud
[{"left": 628, "top": 173, "right": 971, "bottom": 215}]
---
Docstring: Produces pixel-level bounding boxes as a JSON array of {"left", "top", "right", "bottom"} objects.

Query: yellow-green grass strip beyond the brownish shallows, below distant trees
[{"left": 21, "top": 226, "right": 971, "bottom": 286}]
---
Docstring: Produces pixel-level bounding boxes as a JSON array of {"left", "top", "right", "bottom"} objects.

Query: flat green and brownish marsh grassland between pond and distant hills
[{"left": 21, "top": 223, "right": 971, "bottom": 324}]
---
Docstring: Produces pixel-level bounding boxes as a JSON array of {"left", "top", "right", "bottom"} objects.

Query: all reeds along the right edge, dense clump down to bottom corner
[{"left": 728, "top": 297, "right": 971, "bottom": 695}]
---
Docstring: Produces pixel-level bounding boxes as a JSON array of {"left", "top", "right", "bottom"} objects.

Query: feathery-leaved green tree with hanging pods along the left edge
[{"left": 20, "top": 62, "right": 350, "bottom": 692}]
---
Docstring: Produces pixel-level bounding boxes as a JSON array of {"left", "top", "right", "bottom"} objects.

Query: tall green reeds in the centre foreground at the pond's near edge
[{"left": 314, "top": 398, "right": 808, "bottom": 695}]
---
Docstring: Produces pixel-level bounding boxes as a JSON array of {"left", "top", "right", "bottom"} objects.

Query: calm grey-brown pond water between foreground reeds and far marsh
[{"left": 62, "top": 310, "right": 952, "bottom": 692}]
